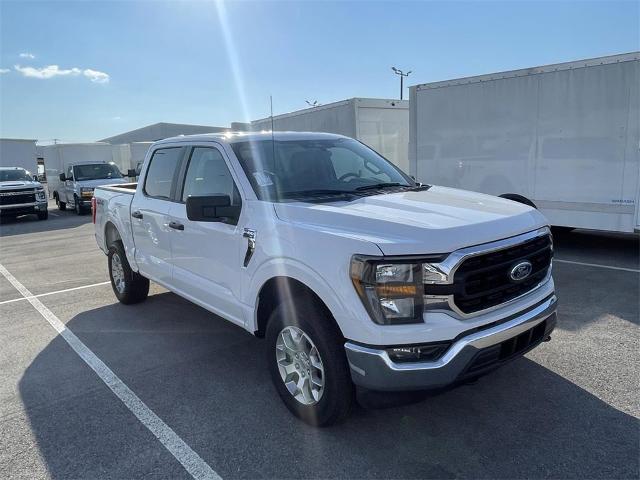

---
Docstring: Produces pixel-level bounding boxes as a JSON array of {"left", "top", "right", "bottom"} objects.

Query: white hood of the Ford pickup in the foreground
[{"left": 275, "top": 186, "right": 548, "bottom": 255}]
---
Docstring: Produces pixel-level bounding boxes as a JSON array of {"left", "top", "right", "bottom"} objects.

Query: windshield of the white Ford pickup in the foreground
[{"left": 231, "top": 138, "right": 415, "bottom": 201}]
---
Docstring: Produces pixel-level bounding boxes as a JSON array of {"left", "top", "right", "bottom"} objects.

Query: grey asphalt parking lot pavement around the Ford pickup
[{"left": 0, "top": 203, "right": 640, "bottom": 479}]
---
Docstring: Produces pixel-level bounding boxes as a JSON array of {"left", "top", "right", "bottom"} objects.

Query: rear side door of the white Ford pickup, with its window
[{"left": 131, "top": 146, "right": 185, "bottom": 286}]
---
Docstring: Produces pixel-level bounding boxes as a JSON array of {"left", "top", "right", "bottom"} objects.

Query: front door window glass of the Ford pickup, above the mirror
[{"left": 182, "top": 147, "right": 241, "bottom": 205}]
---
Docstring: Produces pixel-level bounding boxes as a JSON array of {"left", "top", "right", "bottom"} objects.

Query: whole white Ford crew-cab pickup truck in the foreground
[{"left": 93, "top": 132, "right": 556, "bottom": 425}]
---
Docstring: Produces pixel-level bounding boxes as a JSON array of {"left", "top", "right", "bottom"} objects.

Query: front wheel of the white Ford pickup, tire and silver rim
[{"left": 266, "top": 299, "right": 354, "bottom": 426}]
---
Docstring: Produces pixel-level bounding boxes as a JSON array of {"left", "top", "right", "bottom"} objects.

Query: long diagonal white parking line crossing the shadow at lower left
[{"left": 0, "top": 264, "right": 221, "bottom": 480}]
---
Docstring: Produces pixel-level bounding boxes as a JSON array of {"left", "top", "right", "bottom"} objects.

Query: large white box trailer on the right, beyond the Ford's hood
[{"left": 409, "top": 52, "right": 640, "bottom": 232}]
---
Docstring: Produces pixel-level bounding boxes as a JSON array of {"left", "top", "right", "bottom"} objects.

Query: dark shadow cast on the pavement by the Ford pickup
[{"left": 19, "top": 293, "right": 640, "bottom": 479}]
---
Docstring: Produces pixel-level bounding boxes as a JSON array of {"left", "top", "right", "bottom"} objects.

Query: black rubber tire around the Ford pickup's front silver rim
[{"left": 265, "top": 297, "right": 355, "bottom": 427}]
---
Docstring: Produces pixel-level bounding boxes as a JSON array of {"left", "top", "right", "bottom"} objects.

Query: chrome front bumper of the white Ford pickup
[{"left": 345, "top": 294, "right": 557, "bottom": 390}]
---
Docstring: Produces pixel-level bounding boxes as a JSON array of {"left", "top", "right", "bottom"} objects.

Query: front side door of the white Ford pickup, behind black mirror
[{"left": 170, "top": 146, "right": 246, "bottom": 325}]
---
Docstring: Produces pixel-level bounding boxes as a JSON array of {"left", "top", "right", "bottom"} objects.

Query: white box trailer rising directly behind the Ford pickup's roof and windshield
[{"left": 251, "top": 98, "right": 409, "bottom": 172}]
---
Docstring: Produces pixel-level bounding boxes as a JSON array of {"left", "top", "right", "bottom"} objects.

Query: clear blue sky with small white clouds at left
[{"left": 0, "top": 0, "right": 640, "bottom": 141}]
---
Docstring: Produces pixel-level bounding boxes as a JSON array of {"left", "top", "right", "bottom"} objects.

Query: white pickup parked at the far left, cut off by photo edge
[{"left": 0, "top": 167, "right": 49, "bottom": 220}]
